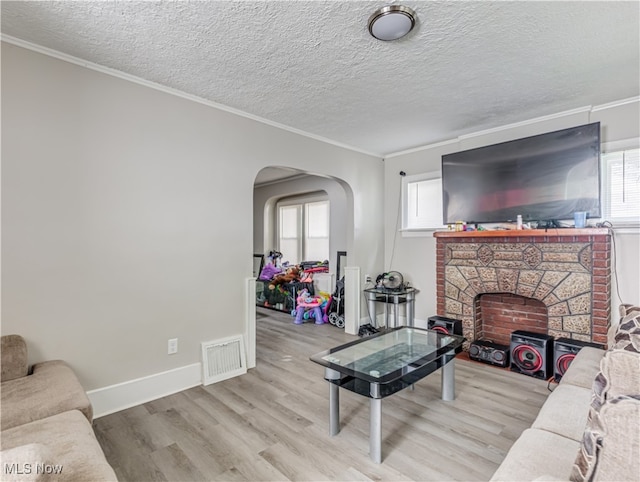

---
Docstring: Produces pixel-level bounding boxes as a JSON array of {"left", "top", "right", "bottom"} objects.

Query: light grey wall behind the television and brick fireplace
[{"left": 384, "top": 99, "right": 640, "bottom": 321}]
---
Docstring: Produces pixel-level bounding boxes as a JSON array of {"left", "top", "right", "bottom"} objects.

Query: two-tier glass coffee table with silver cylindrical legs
[{"left": 311, "top": 326, "right": 464, "bottom": 463}]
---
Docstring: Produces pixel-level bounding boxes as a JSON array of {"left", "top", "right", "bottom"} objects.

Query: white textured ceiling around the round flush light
[{"left": 2, "top": 0, "right": 640, "bottom": 155}]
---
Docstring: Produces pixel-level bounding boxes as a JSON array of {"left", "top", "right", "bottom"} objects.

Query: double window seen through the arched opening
[{"left": 278, "top": 200, "right": 330, "bottom": 264}]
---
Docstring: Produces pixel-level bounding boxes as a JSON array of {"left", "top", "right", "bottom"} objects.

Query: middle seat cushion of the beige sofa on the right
[{"left": 531, "top": 384, "right": 592, "bottom": 440}]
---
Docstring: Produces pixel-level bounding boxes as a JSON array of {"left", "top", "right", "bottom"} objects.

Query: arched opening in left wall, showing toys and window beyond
[{"left": 254, "top": 167, "right": 351, "bottom": 328}]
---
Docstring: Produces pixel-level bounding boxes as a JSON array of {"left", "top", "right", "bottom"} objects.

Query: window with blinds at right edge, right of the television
[{"left": 602, "top": 146, "right": 640, "bottom": 226}]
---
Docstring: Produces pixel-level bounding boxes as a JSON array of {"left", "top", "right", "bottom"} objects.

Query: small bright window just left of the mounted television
[{"left": 402, "top": 172, "right": 443, "bottom": 230}]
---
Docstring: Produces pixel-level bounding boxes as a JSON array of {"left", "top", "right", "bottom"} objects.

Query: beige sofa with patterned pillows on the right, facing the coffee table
[{"left": 491, "top": 305, "right": 640, "bottom": 482}]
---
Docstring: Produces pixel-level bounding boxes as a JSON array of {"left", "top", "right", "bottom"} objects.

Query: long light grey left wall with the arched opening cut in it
[{"left": 2, "top": 43, "right": 383, "bottom": 396}]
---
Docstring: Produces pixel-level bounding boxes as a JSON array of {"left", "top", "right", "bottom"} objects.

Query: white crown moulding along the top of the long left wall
[{"left": 0, "top": 34, "right": 384, "bottom": 159}]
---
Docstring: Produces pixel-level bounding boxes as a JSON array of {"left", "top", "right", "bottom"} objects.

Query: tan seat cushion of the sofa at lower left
[{"left": 1, "top": 410, "right": 117, "bottom": 482}]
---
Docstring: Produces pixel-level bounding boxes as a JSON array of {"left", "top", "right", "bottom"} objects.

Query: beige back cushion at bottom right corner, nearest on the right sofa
[{"left": 571, "top": 396, "right": 640, "bottom": 482}]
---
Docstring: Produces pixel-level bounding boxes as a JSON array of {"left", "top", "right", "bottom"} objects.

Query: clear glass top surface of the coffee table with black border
[{"left": 311, "top": 326, "right": 464, "bottom": 383}]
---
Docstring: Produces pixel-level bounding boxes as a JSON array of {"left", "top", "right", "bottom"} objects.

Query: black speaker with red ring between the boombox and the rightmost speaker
[{"left": 510, "top": 330, "right": 553, "bottom": 380}]
